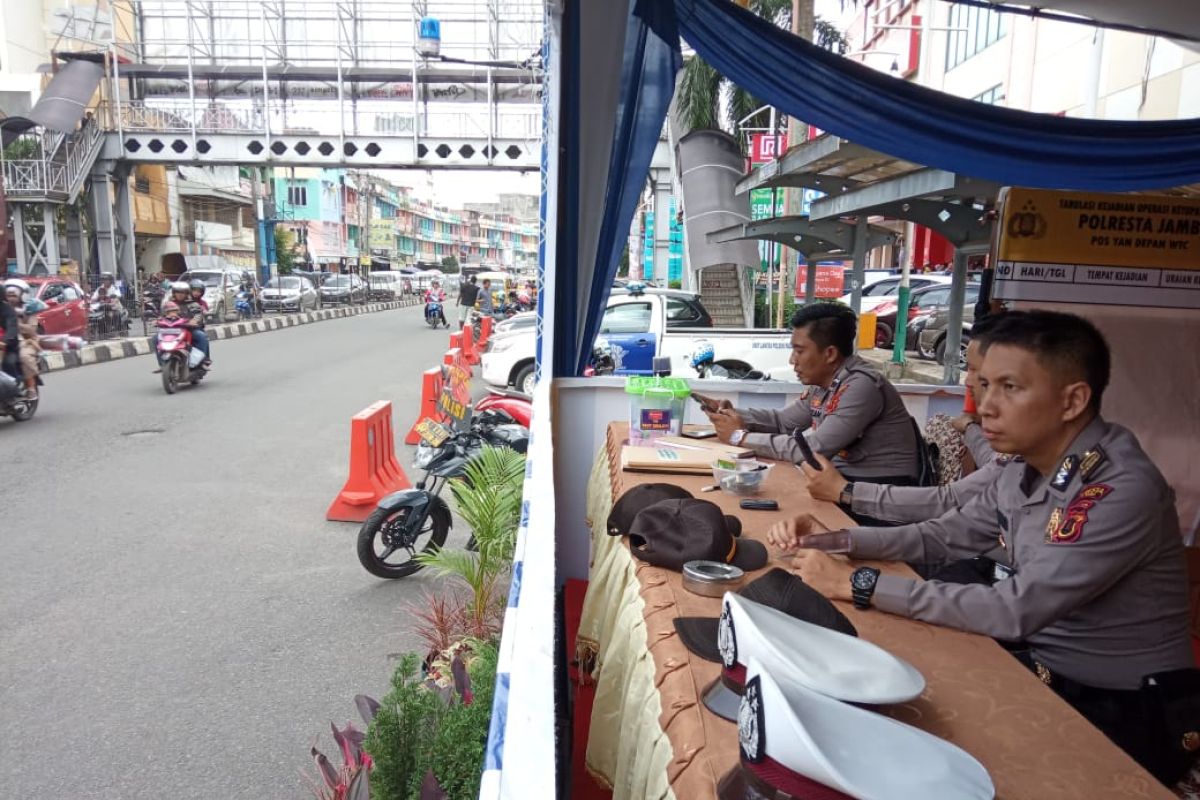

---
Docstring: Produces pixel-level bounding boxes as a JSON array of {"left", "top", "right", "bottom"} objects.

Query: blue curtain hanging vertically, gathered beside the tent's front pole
[{"left": 564, "top": 0, "right": 683, "bottom": 375}]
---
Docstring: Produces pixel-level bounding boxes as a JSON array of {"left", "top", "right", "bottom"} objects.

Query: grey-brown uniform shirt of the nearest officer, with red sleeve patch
[{"left": 851, "top": 417, "right": 1193, "bottom": 690}]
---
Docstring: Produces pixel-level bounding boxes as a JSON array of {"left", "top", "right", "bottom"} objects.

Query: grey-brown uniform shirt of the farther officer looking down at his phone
[{"left": 738, "top": 355, "right": 917, "bottom": 480}]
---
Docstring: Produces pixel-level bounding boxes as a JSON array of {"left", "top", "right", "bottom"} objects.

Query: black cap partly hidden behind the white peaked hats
[{"left": 674, "top": 567, "right": 858, "bottom": 663}]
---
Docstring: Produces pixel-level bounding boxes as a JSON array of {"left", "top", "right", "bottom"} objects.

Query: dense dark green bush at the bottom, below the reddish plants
[{"left": 365, "top": 640, "right": 498, "bottom": 800}]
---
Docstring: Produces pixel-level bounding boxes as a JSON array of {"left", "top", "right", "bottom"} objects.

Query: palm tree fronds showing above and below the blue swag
[{"left": 677, "top": 0, "right": 853, "bottom": 139}]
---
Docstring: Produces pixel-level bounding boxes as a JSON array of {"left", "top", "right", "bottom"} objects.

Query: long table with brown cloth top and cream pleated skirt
[{"left": 576, "top": 422, "right": 1175, "bottom": 800}]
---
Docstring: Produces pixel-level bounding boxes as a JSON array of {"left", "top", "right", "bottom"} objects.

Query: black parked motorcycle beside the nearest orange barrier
[{"left": 358, "top": 410, "right": 529, "bottom": 578}]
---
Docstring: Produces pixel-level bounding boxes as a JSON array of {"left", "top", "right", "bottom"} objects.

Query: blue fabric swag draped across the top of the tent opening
[{"left": 674, "top": 0, "right": 1200, "bottom": 192}]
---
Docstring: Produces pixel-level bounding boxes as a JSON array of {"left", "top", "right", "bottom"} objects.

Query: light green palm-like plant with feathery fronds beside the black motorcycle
[{"left": 416, "top": 447, "right": 524, "bottom": 631}]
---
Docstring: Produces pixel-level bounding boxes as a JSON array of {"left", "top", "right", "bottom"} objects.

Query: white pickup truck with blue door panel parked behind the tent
[{"left": 481, "top": 289, "right": 794, "bottom": 393}]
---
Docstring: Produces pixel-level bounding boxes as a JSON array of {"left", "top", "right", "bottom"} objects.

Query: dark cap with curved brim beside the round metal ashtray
[{"left": 629, "top": 499, "right": 767, "bottom": 571}]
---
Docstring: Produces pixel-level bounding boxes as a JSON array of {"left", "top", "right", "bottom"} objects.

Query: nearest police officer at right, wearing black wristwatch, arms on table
[{"left": 768, "top": 311, "right": 1200, "bottom": 783}]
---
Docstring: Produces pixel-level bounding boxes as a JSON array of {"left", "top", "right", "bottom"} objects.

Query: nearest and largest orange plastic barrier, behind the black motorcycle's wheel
[{"left": 325, "top": 401, "right": 413, "bottom": 522}]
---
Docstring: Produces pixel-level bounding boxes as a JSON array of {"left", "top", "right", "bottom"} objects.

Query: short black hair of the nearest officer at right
[{"left": 984, "top": 311, "right": 1112, "bottom": 411}]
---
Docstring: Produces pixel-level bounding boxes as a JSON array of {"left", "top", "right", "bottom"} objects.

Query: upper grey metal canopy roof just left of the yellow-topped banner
[{"left": 737, "top": 134, "right": 1000, "bottom": 247}]
